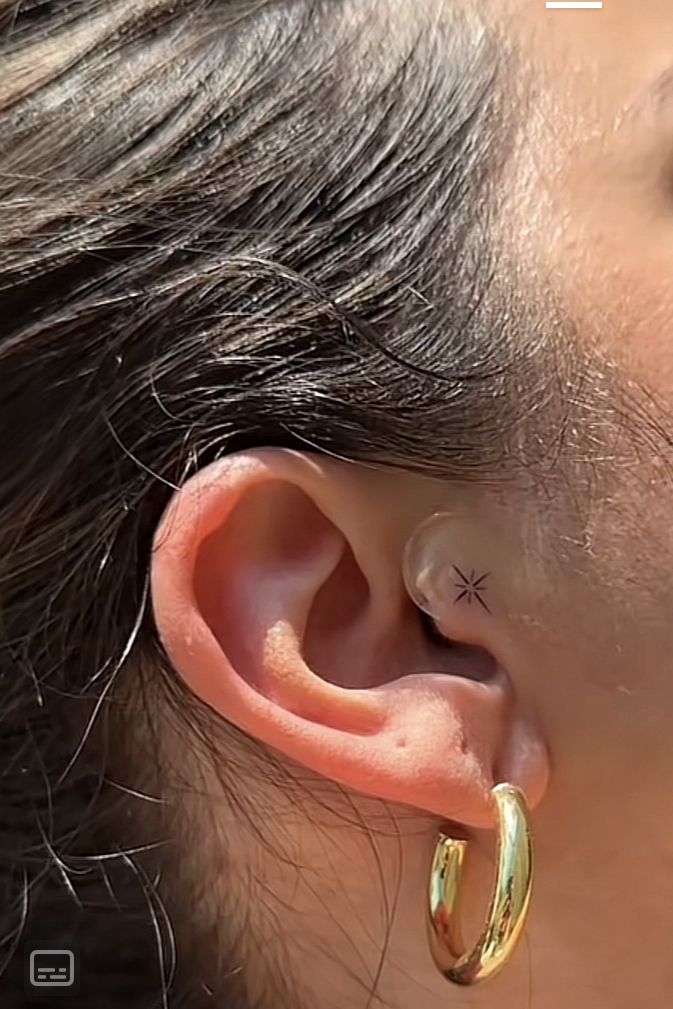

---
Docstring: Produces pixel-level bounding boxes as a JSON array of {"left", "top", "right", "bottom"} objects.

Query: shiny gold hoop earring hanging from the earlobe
[{"left": 428, "top": 784, "right": 533, "bottom": 985}]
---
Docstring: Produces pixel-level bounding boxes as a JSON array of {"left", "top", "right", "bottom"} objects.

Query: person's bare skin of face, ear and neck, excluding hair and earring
[{"left": 151, "top": 0, "right": 673, "bottom": 1009}]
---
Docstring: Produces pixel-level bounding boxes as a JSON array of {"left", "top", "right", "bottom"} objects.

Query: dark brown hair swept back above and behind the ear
[{"left": 0, "top": 0, "right": 534, "bottom": 1009}]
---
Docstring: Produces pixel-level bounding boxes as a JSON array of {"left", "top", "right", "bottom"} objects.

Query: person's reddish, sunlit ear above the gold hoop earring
[{"left": 151, "top": 449, "right": 547, "bottom": 827}]
